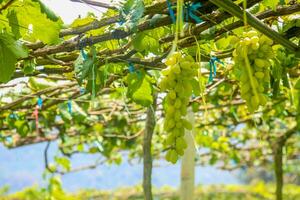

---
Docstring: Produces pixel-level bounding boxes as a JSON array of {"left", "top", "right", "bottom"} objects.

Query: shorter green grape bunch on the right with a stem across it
[{"left": 233, "top": 31, "right": 274, "bottom": 112}]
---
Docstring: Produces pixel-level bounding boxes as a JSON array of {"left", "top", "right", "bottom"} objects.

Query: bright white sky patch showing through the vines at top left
[{"left": 42, "top": 0, "right": 110, "bottom": 24}]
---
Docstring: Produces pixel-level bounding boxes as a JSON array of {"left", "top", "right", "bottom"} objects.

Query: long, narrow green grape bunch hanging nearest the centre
[{"left": 159, "top": 52, "right": 199, "bottom": 163}]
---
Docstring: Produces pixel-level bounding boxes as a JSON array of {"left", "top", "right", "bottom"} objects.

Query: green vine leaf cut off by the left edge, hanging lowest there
[{"left": 0, "top": 32, "right": 28, "bottom": 83}]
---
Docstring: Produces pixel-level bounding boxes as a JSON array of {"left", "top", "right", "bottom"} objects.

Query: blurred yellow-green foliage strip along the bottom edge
[{"left": 5, "top": 184, "right": 300, "bottom": 200}]
